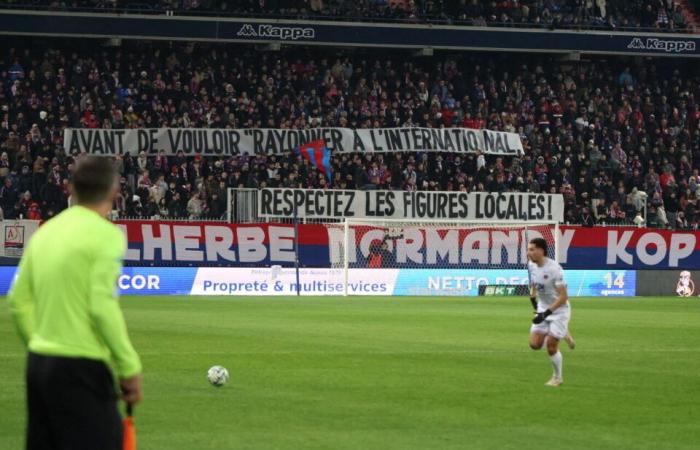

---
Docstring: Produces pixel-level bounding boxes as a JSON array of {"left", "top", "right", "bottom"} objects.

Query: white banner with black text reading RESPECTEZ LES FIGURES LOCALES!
[{"left": 258, "top": 188, "right": 564, "bottom": 222}]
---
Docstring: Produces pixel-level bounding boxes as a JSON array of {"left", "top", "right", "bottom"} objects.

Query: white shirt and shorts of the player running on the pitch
[{"left": 528, "top": 258, "right": 571, "bottom": 339}]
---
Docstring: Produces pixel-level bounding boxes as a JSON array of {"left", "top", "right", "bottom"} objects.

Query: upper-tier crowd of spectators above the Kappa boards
[{"left": 5, "top": 0, "right": 687, "bottom": 31}]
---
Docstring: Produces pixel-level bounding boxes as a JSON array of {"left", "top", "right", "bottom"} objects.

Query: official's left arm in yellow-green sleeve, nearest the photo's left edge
[{"left": 8, "top": 244, "right": 36, "bottom": 347}]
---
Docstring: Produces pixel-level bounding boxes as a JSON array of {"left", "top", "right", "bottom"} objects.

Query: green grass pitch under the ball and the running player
[{"left": 0, "top": 297, "right": 700, "bottom": 450}]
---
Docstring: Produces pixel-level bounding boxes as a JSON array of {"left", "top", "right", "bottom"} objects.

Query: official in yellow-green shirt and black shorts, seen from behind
[{"left": 9, "top": 156, "right": 141, "bottom": 450}]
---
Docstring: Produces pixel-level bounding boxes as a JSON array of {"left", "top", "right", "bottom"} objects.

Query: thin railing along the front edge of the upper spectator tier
[{"left": 0, "top": 1, "right": 693, "bottom": 33}]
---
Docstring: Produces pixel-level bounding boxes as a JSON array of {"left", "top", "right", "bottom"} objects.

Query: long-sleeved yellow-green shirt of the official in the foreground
[{"left": 9, "top": 206, "right": 141, "bottom": 378}]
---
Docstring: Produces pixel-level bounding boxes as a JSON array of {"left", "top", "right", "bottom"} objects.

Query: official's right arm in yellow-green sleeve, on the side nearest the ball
[{"left": 89, "top": 229, "right": 141, "bottom": 379}]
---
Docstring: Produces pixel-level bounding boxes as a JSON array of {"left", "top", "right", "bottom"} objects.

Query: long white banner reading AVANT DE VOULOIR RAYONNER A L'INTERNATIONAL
[{"left": 63, "top": 128, "right": 523, "bottom": 156}]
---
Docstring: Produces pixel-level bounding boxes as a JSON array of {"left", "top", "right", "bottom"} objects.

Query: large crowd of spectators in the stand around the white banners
[{"left": 0, "top": 40, "right": 700, "bottom": 228}]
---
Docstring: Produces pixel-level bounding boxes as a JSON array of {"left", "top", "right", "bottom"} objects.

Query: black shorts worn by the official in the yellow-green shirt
[{"left": 27, "top": 353, "right": 122, "bottom": 450}]
